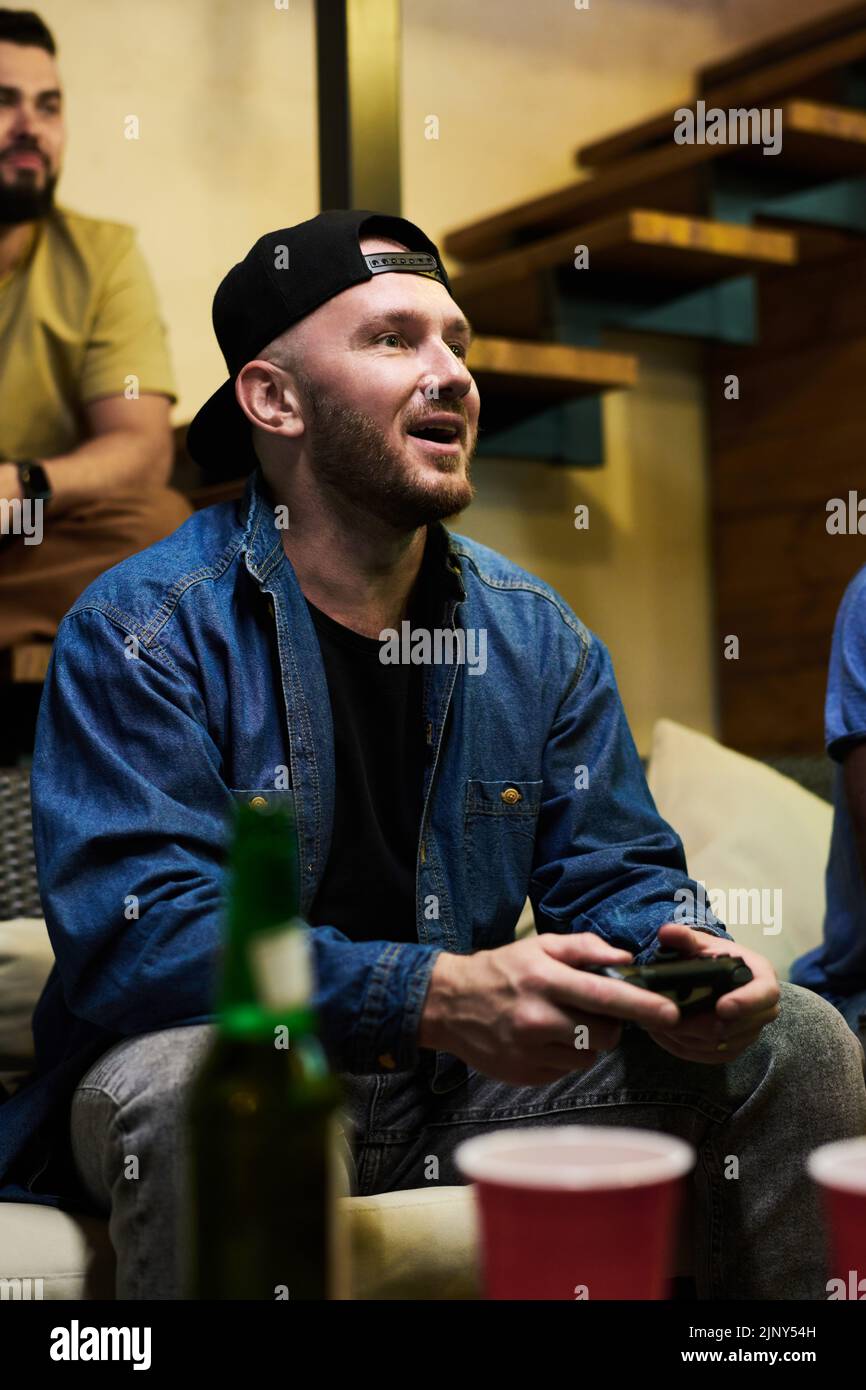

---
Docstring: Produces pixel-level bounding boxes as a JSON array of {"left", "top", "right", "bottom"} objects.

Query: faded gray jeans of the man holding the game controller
[{"left": 71, "top": 984, "right": 866, "bottom": 1300}]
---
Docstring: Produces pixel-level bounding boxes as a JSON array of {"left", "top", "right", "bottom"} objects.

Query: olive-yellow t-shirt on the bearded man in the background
[{"left": 0, "top": 206, "right": 177, "bottom": 459}]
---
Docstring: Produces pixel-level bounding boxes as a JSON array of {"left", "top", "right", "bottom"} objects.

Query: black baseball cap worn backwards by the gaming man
[{"left": 186, "top": 207, "right": 450, "bottom": 480}]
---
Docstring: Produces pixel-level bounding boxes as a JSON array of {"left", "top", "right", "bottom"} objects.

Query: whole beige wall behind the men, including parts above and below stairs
[{"left": 39, "top": 0, "right": 838, "bottom": 752}]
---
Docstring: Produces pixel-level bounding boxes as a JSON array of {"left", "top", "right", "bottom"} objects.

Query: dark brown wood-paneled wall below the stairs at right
[{"left": 708, "top": 243, "right": 866, "bottom": 756}]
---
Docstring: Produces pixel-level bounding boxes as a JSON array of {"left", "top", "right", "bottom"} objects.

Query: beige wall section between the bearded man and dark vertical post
[{"left": 35, "top": 0, "right": 318, "bottom": 423}]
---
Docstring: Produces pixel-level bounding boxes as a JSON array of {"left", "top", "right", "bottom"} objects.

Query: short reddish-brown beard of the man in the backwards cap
[{"left": 295, "top": 370, "right": 475, "bottom": 531}]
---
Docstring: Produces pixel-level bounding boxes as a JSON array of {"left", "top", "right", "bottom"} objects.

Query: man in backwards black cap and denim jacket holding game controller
[{"left": 0, "top": 210, "right": 866, "bottom": 1298}]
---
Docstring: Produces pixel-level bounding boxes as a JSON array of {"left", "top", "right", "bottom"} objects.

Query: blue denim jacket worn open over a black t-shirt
[{"left": 0, "top": 471, "right": 727, "bottom": 1201}]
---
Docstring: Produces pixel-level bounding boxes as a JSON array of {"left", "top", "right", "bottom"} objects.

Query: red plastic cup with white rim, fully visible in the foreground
[{"left": 455, "top": 1125, "right": 696, "bottom": 1300}]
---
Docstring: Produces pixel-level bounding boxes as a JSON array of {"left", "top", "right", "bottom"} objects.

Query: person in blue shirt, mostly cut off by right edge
[{"left": 791, "top": 566, "right": 866, "bottom": 1037}]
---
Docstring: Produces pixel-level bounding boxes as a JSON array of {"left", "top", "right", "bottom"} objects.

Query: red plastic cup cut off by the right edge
[{"left": 806, "top": 1138, "right": 866, "bottom": 1300}]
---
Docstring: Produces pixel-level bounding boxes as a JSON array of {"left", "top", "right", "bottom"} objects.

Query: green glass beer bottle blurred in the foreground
[{"left": 183, "top": 798, "right": 348, "bottom": 1300}]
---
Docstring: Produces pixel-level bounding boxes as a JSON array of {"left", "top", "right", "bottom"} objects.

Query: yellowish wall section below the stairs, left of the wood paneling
[{"left": 455, "top": 334, "right": 713, "bottom": 753}]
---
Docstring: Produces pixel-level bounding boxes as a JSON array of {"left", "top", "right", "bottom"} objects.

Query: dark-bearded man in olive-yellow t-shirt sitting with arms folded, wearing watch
[{"left": 0, "top": 10, "right": 192, "bottom": 649}]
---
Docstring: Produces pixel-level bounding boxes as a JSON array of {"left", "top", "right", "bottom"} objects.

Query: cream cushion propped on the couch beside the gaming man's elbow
[{"left": 648, "top": 719, "right": 833, "bottom": 979}]
